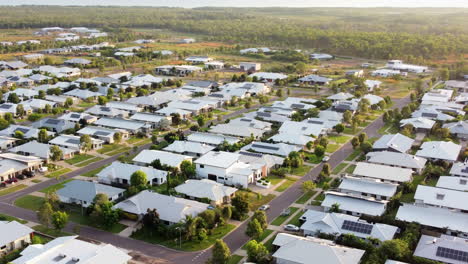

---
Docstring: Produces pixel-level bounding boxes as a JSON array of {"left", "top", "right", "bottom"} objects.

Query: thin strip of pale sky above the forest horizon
[{"left": 0, "top": 0, "right": 468, "bottom": 8}]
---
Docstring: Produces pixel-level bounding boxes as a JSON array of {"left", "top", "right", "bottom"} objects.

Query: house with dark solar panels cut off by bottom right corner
[{"left": 414, "top": 235, "right": 468, "bottom": 264}]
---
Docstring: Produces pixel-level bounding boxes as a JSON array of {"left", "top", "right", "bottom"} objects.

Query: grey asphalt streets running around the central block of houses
[{"left": 0, "top": 94, "right": 410, "bottom": 264}]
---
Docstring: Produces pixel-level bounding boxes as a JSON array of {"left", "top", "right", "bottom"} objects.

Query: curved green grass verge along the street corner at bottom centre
[{"left": 131, "top": 224, "right": 236, "bottom": 251}]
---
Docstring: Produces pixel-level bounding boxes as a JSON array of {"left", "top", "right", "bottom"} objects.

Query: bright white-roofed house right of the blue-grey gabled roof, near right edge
[{"left": 416, "top": 141, "right": 461, "bottom": 162}]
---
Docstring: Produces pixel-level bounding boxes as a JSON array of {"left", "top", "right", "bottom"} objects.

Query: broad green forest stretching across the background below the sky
[{"left": 0, "top": 6, "right": 468, "bottom": 61}]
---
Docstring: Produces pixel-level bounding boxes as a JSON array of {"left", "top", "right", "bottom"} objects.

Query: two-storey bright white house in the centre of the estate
[{"left": 195, "top": 151, "right": 262, "bottom": 188}]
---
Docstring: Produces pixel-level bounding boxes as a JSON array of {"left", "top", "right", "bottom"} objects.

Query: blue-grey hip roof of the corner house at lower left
[{"left": 57, "top": 180, "right": 125, "bottom": 204}]
